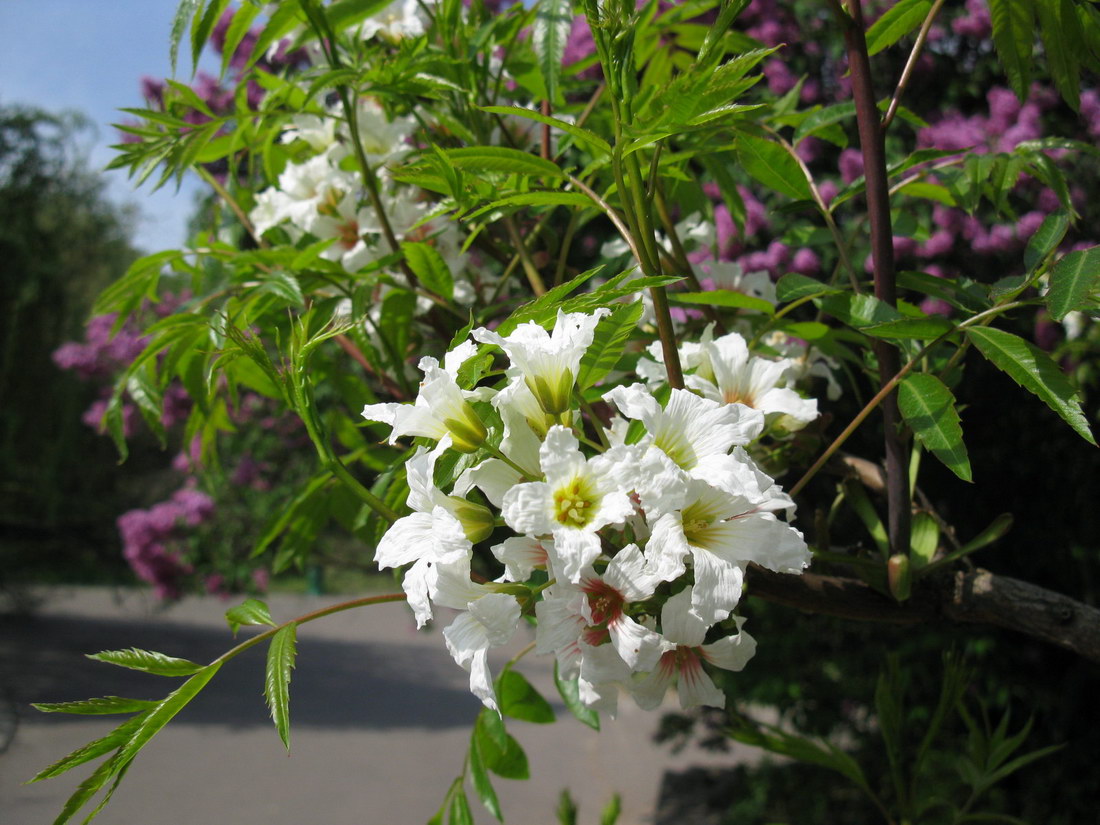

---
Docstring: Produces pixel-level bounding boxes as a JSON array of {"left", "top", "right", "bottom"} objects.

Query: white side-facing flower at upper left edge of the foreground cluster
[{"left": 363, "top": 341, "right": 486, "bottom": 452}]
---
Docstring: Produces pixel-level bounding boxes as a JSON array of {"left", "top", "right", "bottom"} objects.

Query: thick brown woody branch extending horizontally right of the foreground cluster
[{"left": 746, "top": 564, "right": 1100, "bottom": 663}]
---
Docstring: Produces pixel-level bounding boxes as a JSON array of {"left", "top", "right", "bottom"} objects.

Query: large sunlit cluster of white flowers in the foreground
[{"left": 363, "top": 310, "right": 813, "bottom": 712}]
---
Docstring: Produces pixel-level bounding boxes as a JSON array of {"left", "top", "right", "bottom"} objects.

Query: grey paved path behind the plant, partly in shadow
[{"left": 0, "top": 589, "right": 748, "bottom": 825}]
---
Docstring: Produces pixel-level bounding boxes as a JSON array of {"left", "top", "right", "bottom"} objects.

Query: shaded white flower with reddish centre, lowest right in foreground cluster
[{"left": 631, "top": 591, "right": 756, "bottom": 711}]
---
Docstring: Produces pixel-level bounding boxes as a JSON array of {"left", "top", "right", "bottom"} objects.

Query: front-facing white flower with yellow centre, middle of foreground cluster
[{"left": 503, "top": 425, "right": 634, "bottom": 582}]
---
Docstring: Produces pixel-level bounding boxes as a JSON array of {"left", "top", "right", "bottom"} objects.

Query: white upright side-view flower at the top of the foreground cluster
[{"left": 473, "top": 308, "right": 611, "bottom": 416}]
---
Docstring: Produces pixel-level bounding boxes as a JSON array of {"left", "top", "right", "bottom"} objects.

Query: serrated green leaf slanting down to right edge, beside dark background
[{"left": 967, "top": 327, "right": 1096, "bottom": 446}]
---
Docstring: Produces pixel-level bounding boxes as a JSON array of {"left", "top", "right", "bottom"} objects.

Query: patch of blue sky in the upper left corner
[{"left": 0, "top": 0, "right": 207, "bottom": 252}]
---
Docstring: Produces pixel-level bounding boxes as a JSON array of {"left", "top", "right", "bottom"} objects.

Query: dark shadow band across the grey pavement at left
[{"left": 0, "top": 616, "right": 481, "bottom": 729}]
